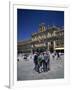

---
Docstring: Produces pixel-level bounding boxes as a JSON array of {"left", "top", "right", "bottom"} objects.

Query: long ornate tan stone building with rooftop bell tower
[{"left": 17, "top": 23, "right": 64, "bottom": 52}]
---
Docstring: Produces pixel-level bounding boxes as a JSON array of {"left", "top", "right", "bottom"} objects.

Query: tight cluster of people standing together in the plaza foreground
[{"left": 34, "top": 52, "right": 50, "bottom": 73}]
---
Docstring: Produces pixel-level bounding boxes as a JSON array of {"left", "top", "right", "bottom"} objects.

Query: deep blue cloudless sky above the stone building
[{"left": 17, "top": 9, "right": 64, "bottom": 41}]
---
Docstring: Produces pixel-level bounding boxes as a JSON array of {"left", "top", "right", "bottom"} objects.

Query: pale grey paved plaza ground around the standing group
[{"left": 17, "top": 56, "right": 64, "bottom": 81}]
